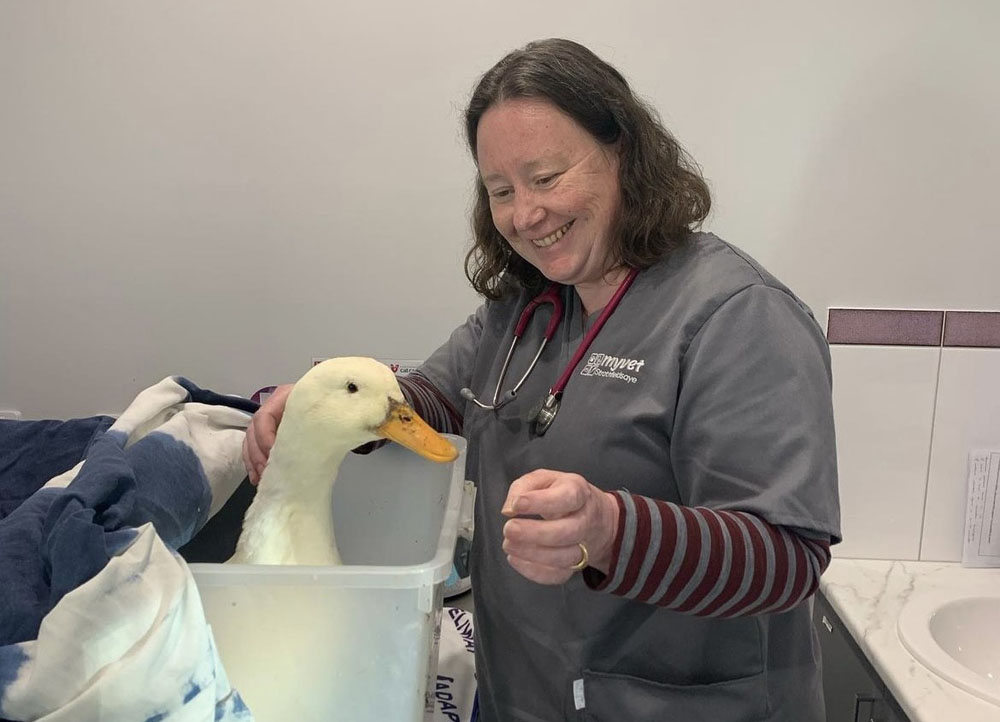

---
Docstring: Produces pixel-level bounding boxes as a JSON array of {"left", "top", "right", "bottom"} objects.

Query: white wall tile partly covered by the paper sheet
[{"left": 920, "top": 346, "right": 1000, "bottom": 561}]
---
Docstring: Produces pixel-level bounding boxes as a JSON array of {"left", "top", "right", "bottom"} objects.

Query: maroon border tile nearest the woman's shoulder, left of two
[{"left": 826, "top": 308, "right": 944, "bottom": 346}]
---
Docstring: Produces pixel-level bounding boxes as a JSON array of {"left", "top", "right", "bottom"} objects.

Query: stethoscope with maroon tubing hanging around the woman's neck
[{"left": 460, "top": 268, "right": 639, "bottom": 436}]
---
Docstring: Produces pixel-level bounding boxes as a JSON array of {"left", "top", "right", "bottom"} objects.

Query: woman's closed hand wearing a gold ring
[{"left": 502, "top": 469, "right": 618, "bottom": 584}]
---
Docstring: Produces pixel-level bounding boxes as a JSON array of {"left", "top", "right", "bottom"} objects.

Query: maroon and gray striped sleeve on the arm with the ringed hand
[{"left": 584, "top": 491, "right": 830, "bottom": 617}]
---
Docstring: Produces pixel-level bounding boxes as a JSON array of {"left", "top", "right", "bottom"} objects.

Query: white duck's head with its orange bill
[{"left": 282, "top": 357, "right": 458, "bottom": 462}]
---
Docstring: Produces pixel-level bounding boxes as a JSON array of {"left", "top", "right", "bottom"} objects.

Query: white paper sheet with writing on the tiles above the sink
[{"left": 962, "top": 450, "right": 1000, "bottom": 567}]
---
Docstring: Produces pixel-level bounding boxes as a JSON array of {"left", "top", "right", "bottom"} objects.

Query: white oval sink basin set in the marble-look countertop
[{"left": 897, "top": 592, "right": 1000, "bottom": 705}]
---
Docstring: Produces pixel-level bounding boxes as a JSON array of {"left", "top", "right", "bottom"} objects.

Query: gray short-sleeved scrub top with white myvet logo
[{"left": 421, "top": 234, "right": 840, "bottom": 722}]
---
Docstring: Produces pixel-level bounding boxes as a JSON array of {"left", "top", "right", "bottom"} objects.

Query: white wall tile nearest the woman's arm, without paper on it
[{"left": 831, "top": 345, "right": 941, "bottom": 560}]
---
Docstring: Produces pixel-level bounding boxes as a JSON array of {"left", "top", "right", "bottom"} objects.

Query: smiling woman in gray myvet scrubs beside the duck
[{"left": 245, "top": 40, "right": 840, "bottom": 722}]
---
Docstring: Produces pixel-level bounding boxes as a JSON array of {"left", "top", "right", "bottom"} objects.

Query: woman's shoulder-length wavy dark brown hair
[{"left": 465, "top": 38, "right": 712, "bottom": 299}]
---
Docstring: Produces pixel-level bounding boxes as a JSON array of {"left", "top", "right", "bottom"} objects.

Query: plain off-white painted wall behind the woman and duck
[{"left": 0, "top": 0, "right": 1000, "bottom": 418}]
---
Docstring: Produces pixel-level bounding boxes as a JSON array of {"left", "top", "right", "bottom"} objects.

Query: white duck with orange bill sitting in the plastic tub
[{"left": 229, "top": 357, "right": 458, "bottom": 565}]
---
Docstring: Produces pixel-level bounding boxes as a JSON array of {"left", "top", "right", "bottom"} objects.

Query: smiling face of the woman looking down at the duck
[{"left": 476, "top": 98, "right": 621, "bottom": 310}]
